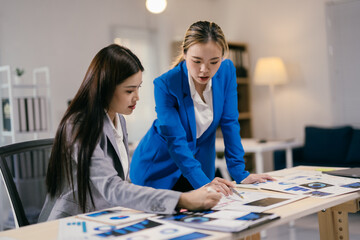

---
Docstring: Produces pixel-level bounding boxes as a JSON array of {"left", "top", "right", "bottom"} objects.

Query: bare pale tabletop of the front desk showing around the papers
[{"left": 0, "top": 166, "right": 360, "bottom": 240}]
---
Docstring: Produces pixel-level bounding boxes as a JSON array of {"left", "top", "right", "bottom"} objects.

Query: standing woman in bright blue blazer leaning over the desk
[{"left": 130, "top": 21, "right": 273, "bottom": 195}]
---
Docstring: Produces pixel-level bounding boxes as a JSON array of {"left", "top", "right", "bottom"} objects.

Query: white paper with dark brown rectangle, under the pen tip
[{"left": 213, "top": 191, "right": 306, "bottom": 212}]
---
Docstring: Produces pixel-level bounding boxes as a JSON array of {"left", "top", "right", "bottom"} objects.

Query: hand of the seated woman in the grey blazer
[{"left": 177, "top": 186, "right": 221, "bottom": 210}]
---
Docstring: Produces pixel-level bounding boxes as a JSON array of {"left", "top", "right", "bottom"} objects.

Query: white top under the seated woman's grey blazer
[{"left": 106, "top": 114, "right": 129, "bottom": 180}]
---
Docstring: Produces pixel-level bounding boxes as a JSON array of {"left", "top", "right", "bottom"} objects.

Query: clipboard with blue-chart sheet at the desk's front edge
[{"left": 158, "top": 210, "right": 279, "bottom": 232}]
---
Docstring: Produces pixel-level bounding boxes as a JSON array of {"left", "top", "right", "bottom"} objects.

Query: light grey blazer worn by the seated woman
[{"left": 39, "top": 115, "right": 181, "bottom": 222}]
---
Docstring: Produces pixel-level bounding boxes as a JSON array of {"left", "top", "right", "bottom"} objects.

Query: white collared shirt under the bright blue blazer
[{"left": 188, "top": 73, "right": 214, "bottom": 138}]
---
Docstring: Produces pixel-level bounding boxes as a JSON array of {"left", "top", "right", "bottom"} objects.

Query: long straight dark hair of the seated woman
[{"left": 46, "top": 44, "right": 144, "bottom": 212}]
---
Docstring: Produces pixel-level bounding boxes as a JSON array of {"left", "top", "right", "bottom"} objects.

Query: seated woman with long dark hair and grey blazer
[{"left": 39, "top": 44, "right": 221, "bottom": 222}]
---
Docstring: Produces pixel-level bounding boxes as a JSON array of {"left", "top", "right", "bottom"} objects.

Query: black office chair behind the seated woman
[{"left": 0, "top": 138, "right": 54, "bottom": 228}]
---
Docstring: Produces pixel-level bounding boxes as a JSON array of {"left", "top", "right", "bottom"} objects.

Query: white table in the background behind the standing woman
[{"left": 215, "top": 138, "right": 302, "bottom": 173}]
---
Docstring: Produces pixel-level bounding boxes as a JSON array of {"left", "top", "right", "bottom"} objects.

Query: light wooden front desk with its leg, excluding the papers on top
[{"left": 0, "top": 166, "right": 360, "bottom": 240}]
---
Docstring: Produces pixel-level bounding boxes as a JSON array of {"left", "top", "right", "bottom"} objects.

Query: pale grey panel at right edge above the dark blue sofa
[{"left": 326, "top": 0, "right": 360, "bottom": 128}]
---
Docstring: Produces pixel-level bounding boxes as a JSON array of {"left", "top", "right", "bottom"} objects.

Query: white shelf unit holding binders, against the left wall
[{"left": 0, "top": 66, "right": 52, "bottom": 145}]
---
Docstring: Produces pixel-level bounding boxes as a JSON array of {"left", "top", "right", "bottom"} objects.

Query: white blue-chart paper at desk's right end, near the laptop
[{"left": 243, "top": 170, "right": 360, "bottom": 198}]
